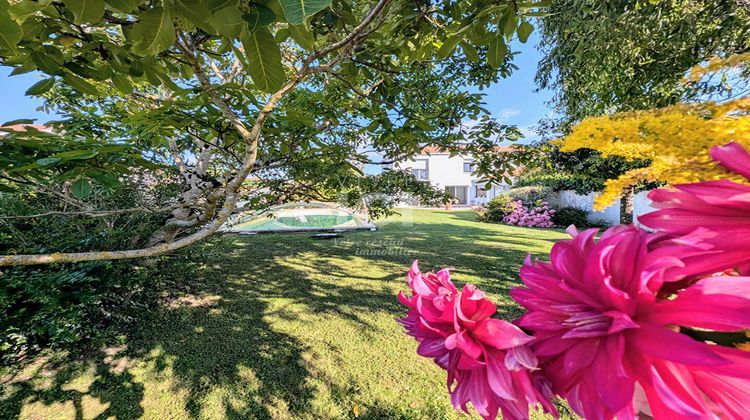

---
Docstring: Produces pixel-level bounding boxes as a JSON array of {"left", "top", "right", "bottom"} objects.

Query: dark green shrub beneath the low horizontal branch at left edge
[{"left": 0, "top": 262, "right": 147, "bottom": 365}]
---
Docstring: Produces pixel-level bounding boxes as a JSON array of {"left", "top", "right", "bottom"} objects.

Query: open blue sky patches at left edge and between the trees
[{"left": 0, "top": 33, "right": 552, "bottom": 149}]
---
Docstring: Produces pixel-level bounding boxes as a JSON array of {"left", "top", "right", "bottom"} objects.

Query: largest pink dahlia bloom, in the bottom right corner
[{"left": 511, "top": 226, "right": 750, "bottom": 419}]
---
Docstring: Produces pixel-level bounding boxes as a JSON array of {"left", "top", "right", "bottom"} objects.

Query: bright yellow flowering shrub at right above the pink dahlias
[{"left": 557, "top": 97, "right": 750, "bottom": 209}]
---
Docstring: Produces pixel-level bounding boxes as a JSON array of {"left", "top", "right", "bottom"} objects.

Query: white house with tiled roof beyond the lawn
[{"left": 393, "top": 146, "right": 512, "bottom": 205}]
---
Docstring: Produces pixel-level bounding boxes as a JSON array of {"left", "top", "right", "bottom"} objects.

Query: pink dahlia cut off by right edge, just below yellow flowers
[{"left": 638, "top": 142, "right": 750, "bottom": 275}]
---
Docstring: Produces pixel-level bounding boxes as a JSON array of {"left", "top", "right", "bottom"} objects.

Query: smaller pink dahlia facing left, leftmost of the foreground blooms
[{"left": 398, "top": 261, "right": 554, "bottom": 419}]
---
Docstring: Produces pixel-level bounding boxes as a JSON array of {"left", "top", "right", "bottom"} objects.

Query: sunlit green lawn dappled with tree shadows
[{"left": 0, "top": 210, "right": 565, "bottom": 419}]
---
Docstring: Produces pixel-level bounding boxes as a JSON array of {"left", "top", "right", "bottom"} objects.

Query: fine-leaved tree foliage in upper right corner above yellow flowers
[{"left": 537, "top": 0, "right": 750, "bottom": 128}]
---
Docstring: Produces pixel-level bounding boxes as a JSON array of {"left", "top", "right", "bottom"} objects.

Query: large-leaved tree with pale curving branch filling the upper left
[{"left": 0, "top": 0, "right": 545, "bottom": 266}]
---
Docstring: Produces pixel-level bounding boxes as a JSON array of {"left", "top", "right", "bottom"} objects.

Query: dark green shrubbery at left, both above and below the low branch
[{"left": 0, "top": 180, "right": 179, "bottom": 365}]
